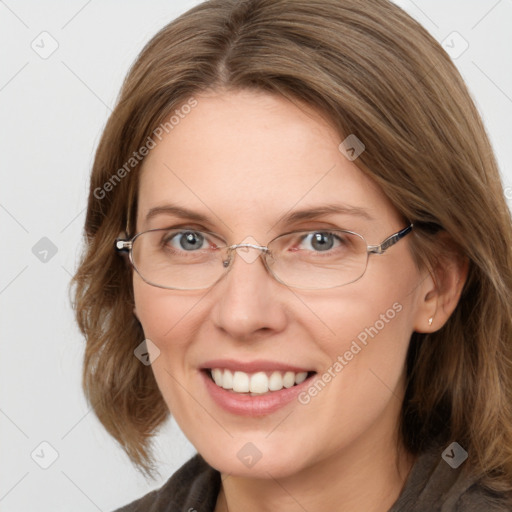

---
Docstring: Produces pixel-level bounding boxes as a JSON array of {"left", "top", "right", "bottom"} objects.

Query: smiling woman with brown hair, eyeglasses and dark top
[{"left": 75, "top": 0, "right": 512, "bottom": 512}]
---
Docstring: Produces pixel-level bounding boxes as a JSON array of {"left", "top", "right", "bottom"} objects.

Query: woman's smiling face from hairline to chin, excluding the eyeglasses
[{"left": 133, "top": 91, "right": 427, "bottom": 477}]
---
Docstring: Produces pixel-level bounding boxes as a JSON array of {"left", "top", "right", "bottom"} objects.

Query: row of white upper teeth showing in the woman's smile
[{"left": 211, "top": 368, "right": 308, "bottom": 393}]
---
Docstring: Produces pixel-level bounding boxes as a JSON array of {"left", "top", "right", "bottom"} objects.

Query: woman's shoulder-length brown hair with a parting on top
[{"left": 74, "top": 0, "right": 512, "bottom": 491}]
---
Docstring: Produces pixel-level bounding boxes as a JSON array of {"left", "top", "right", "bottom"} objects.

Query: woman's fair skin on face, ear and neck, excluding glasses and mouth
[{"left": 133, "top": 91, "right": 464, "bottom": 512}]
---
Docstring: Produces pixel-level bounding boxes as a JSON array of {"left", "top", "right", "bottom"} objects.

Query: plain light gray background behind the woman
[{"left": 0, "top": 0, "right": 512, "bottom": 512}]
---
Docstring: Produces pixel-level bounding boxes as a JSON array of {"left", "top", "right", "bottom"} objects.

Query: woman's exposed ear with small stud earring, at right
[{"left": 414, "top": 232, "right": 469, "bottom": 333}]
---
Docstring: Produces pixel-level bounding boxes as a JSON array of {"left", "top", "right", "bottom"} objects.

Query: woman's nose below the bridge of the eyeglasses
[{"left": 212, "top": 247, "right": 287, "bottom": 341}]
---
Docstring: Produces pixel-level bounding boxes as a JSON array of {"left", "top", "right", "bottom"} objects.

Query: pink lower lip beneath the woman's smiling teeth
[{"left": 201, "top": 370, "right": 314, "bottom": 416}]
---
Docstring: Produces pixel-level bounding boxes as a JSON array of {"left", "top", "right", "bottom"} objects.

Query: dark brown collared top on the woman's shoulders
[{"left": 115, "top": 446, "right": 512, "bottom": 512}]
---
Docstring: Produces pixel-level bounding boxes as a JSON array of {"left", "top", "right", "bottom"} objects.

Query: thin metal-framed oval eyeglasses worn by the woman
[{"left": 115, "top": 224, "right": 413, "bottom": 290}]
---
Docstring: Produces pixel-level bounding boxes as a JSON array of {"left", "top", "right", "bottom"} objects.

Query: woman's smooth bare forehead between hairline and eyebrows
[{"left": 137, "top": 91, "right": 396, "bottom": 235}]
